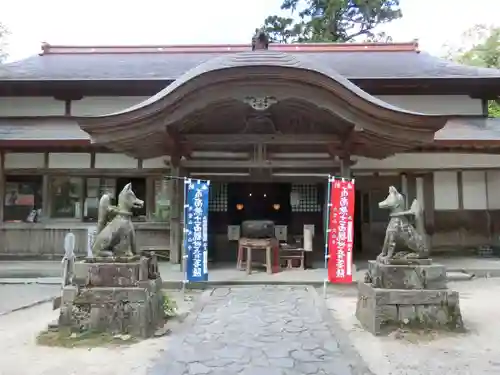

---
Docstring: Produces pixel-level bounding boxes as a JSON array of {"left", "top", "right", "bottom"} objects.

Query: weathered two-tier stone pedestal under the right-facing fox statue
[{"left": 59, "top": 257, "right": 164, "bottom": 338}]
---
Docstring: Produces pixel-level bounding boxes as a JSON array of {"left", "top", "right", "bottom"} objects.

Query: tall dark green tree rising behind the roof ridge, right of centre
[{"left": 258, "top": 0, "right": 402, "bottom": 43}]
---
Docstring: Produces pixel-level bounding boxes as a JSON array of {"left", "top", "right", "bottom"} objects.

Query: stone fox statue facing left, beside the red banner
[{"left": 377, "top": 186, "right": 429, "bottom": 262}]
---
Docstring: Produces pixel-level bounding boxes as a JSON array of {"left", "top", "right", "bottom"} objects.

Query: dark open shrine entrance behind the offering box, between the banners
[{"left": 205, "top": 181, "right": 363, "bottom": 267}]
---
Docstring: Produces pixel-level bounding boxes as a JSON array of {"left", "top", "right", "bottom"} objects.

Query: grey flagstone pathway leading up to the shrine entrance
[{"left": 148, "top": 286, "right": 370, "bottom": 375}]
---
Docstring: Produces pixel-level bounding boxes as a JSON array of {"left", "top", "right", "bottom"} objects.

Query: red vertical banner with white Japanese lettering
[{"left": 328, "top": 178, "right": 355, "bottom": 283}]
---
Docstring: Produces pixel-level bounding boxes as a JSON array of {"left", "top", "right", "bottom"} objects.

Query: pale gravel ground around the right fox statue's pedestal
[{"left": 328, "top": 279, "right": 500, "bottom": 375}]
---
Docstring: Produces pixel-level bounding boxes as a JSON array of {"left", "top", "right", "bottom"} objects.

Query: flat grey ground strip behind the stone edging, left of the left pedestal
[{"left": 0, "top": 284, "right": 61, "bottom": 315}]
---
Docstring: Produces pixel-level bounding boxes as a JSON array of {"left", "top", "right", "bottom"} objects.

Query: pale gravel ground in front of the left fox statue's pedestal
[{"left": 0, "top": 292, "right": 196, "bottom": 375}]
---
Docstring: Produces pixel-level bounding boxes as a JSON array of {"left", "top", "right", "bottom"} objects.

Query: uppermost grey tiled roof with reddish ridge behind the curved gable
[{"left": 0, "top": 43, "right": 500, "bottom": 81}]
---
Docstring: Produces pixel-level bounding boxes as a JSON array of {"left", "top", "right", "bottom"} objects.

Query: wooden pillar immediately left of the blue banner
[{"left": 169, "top": 166, "right": 184, "bottom": 264}]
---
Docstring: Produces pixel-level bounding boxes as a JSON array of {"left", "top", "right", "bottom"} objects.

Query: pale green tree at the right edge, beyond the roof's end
[{"left": 446, "top": 25, "right": 500, "bottom": 117}]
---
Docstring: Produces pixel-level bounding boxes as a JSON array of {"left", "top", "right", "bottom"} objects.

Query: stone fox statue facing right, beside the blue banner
[{"left": 92, "top": 183, "right": 144, "bottom": 257}]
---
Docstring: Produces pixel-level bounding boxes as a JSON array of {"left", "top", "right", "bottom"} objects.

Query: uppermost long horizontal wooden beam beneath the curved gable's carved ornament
[{"left": 183, "top": 134, "right": 340, "bottom": 146}]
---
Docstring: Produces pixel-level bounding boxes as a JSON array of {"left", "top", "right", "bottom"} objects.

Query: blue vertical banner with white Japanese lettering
[{"left": 184, "top": 179, "right": 210, "bottom": 282}]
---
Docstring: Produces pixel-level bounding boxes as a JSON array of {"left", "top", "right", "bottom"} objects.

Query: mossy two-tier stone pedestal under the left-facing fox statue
[{"left": 356, "top": 259, "right": 463, "bottom": 334}]
